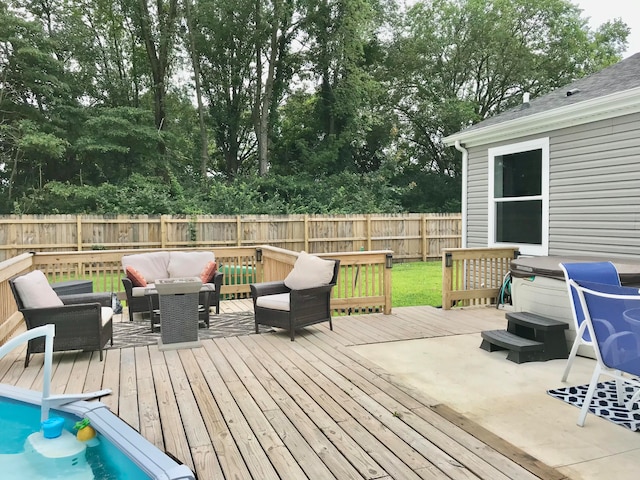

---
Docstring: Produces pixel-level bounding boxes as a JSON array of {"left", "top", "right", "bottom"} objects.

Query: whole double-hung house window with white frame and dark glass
[{"left": 488, "top": 138, "right": 549, "bottom": 255}]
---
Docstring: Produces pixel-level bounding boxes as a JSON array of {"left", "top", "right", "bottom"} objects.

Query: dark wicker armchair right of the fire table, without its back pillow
[{"left": 250, "top": 260, "right": 340, "bottom": 341}]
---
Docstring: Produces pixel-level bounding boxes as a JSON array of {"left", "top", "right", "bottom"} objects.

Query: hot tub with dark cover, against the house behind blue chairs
[{"left": 511, "top": 256, "right": 640, "bottom": 358}]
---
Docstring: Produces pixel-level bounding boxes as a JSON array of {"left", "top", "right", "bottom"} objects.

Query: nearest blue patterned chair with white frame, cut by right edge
[{"left": 569, "top": 280, "right": 640, "bottom": 427}]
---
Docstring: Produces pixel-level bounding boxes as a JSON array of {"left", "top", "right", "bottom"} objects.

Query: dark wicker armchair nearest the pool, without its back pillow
[{"left": 9, "top": 277, "right": 113, "bottom": 367}]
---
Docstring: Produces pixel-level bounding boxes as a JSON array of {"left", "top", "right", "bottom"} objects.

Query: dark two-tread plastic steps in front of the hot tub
[{"left": 480, "top": 312, "right": 569, "bottom": 363}]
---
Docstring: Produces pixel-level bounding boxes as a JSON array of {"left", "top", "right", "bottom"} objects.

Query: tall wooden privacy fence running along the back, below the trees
[{"left": 0, "top": 213, "right": 462, "bottom": 261}]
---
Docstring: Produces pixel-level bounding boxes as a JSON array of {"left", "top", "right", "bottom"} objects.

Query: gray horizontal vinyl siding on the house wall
[{"left": 467, "top": 110, "right": 640, "bottom": 257}]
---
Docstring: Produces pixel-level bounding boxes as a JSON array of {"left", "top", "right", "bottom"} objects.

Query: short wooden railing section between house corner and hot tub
[{"left": 442, "top": 247, "right": 519, "bottom": 310}]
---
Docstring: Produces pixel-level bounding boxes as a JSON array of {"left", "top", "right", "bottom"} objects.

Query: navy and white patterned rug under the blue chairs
[{"left": 547, "top": 380, "right": 640, "bottom": 432}]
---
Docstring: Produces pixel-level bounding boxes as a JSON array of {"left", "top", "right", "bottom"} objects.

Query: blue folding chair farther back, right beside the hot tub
[{"left": 560, "top": 262, "right": 620, "bottom": 382}]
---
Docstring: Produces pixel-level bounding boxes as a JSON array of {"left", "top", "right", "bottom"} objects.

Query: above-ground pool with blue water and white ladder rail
[{"left": 0, "top": 325, "right": 195, "bottom": 480}]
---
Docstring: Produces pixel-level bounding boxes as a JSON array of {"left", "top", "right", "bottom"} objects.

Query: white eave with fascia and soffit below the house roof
[{"left": 442, "top": 87, "right": 640, "bottom": 147}]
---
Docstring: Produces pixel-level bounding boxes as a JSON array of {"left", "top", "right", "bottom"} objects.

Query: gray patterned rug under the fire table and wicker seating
[{"left": 107, "top": 311, "right": 262, "bottom": 348}]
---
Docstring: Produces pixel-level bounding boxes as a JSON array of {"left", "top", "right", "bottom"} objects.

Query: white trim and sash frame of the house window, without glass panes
[{"left": 487, "top": 137, "right": 549, "bottom": 255}]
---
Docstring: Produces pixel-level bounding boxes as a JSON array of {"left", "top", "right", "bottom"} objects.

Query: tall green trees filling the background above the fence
[{"left": 0, "top": 0, "right": 629, "bottom": 214}]
